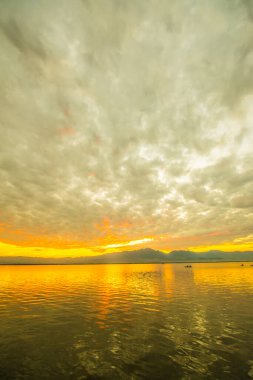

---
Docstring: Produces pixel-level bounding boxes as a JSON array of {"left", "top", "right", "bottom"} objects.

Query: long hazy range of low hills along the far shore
[{"left": 0, "top": 248, "right": 253, "bottom": 265}]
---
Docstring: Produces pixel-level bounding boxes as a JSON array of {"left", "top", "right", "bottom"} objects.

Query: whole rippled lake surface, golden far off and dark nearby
[{"left": 0, "top": 263, "right": 253, "bottom": 380}]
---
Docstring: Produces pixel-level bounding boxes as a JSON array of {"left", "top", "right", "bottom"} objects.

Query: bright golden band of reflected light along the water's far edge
[{"left": 0, "top": 263, "right": 253, "bottom": 296}]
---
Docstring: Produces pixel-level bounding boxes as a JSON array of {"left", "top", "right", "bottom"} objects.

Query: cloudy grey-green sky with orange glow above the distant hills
[{"left": 0, "top": 0, "right": 253, "bottom": 257}]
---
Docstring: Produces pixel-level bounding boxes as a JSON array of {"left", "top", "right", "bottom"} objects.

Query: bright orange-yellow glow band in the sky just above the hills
[{"left": 0, "top": 221, "right": 253, "bottom": 258}]
